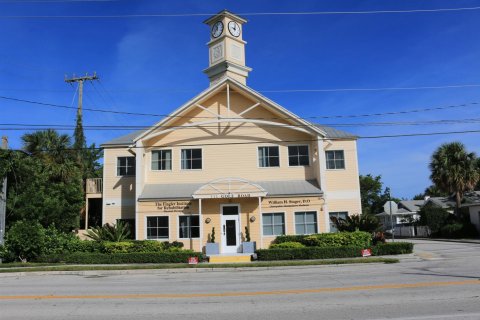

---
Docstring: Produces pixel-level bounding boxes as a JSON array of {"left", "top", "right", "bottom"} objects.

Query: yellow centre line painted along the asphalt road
[{"left": 0, "top": 279, "right": 480, "bottom": 300}]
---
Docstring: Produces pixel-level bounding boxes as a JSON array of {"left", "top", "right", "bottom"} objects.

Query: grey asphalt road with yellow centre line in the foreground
[{"left": 0, "top": 241, "right": 480, "bottom": 320}]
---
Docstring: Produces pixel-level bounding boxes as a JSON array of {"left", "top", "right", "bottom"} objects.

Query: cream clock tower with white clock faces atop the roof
[{"left": 204, "top": 10, "right": 252, "bottom": 85}]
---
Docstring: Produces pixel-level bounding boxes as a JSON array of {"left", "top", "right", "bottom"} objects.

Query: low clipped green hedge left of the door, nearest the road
[{"left": 35, "top": 250, "right": 202, "bottom": 264}]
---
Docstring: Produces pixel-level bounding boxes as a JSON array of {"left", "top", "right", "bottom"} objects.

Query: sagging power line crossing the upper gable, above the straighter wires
[{"left": 0, "top": 96, "right": 479, "bottom": 120}]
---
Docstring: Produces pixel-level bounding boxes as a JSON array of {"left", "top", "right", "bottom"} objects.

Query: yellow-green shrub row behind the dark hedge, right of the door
[{"left": 273, "top": 231, "right": 372, "bottom": 247}]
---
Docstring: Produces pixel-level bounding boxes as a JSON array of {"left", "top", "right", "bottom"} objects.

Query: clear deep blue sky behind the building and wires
[{"left": 0, "top": 0, "right": 480, "bottom": 198}]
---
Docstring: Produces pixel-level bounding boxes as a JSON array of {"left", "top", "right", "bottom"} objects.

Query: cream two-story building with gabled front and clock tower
[{"left": 87, "top": 11, "right": 361, "bottom": 253}]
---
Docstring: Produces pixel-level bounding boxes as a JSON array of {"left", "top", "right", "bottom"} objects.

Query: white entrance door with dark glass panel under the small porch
[{"left": 221, "top": 204, "right": 240, "bottom": 253}]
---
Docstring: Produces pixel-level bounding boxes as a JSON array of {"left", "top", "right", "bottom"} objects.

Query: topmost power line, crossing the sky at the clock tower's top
[{"left": 0, "top": 7, "right": 480, "bottom": 19}]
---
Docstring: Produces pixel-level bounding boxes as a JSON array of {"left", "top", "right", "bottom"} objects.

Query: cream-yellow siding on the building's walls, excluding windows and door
[{"left": 103, "top": 85, "right": 361, "bottom": 245}]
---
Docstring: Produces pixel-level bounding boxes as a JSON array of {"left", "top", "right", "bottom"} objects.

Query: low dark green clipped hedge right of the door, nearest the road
[{"left": 256, "top": 242, "right": 413, "bottom": 261}]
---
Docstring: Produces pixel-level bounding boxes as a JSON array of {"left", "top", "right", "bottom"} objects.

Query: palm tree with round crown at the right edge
[{"left": 429, "top": 142, "right": 480, "bottom": 216}]
